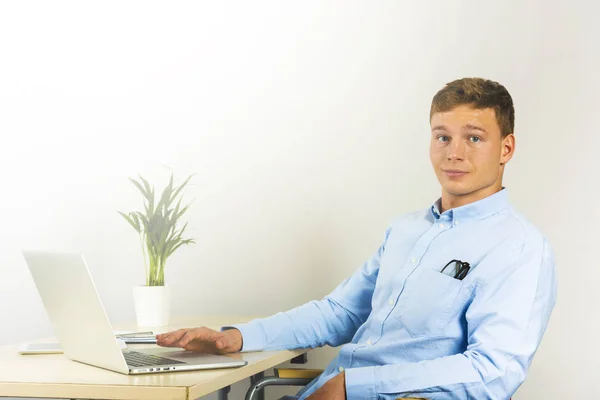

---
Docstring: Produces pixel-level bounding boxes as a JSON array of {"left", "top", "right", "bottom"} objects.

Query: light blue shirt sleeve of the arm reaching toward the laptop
[{"left": 222, "top": 228, "right": 391, "bottom": 351}]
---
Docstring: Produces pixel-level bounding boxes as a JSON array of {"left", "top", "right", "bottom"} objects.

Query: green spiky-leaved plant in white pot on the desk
[{"left": 118, "top": 173, "right": 195, "bottom": 327}]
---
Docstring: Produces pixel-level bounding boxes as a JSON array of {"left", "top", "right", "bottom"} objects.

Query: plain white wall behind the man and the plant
[{"left": 0, "top": 0, "right": 600, "bottom": 400}]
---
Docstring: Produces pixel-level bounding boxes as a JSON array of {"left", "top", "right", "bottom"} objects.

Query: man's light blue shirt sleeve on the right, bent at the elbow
[{"left": 345, "top": 240, "right": 556, "bottom": 400}]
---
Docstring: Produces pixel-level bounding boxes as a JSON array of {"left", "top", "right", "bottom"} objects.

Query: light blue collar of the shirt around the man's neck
[{"left": 431, "top": 187, "right": 510, "bottom": 222}]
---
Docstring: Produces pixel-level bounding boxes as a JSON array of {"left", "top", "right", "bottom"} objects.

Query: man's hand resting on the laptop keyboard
[{"left": 156, "top": 327, "right": 242, "bottom": 354}]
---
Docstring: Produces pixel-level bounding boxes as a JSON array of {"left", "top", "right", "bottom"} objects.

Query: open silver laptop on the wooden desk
[{"left": 23, "top": 251, "right": 247, "bottom": 374}]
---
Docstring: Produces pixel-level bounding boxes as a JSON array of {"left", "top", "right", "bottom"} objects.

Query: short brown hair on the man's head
[{"left": 429, "top": 78, "right": 515, "bottom": 138}]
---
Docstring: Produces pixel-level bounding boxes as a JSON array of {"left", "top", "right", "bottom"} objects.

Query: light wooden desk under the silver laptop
[{"left": 0, "top": 317, "right": 307, "bottom": 400}]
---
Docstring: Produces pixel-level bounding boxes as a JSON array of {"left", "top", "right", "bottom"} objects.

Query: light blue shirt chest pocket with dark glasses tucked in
[{"left": 397, "top": 268, "right": 463, "bottom": 337}]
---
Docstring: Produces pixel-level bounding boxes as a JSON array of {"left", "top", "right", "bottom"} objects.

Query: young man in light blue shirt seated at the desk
[{"left": 157, "top": 78, "right": 556, "bottom": 400}]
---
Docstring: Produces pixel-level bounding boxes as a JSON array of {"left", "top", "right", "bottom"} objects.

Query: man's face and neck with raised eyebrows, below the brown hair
[{"left": 429, "top": 105, "right": 514, "bottom": 207}]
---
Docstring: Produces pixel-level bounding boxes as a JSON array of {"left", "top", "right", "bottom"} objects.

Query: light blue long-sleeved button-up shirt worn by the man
[{"left": 226, "top": 189, "right": 556, "bottom": 400}]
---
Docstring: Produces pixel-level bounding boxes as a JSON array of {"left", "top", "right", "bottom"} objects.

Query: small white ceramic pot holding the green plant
[{"left": 133, "top": 286, "right": 171, "bottom": 327}]
